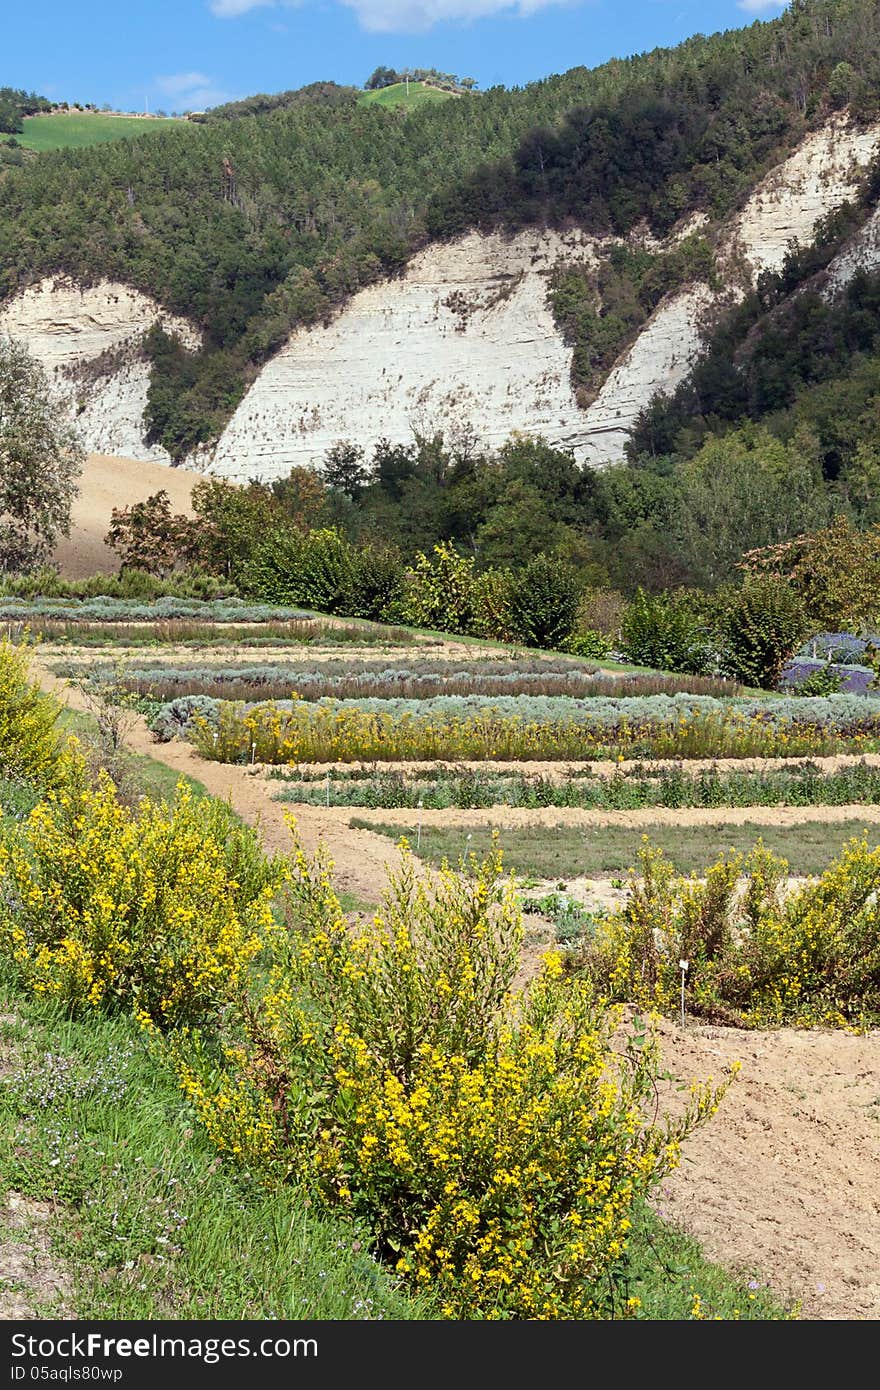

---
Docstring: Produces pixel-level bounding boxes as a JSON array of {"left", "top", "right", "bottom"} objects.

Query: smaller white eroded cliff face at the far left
[{"left": 0, "top": 278, "right": 200, "bottom": 463}]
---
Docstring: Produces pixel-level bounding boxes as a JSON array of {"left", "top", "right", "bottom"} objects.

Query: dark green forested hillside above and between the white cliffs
[{"left": 0, "top": 0, "right": 880, "bottom": 457}]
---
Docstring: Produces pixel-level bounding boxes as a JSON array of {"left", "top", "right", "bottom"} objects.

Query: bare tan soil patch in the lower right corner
[{"left": 658, "top": 1023, "right": 880, "bottom": 1319}]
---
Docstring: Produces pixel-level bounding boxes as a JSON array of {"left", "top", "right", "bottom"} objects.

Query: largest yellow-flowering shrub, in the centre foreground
[{"left": 174, "top": 828, "right": 723, "bottom": 1318}]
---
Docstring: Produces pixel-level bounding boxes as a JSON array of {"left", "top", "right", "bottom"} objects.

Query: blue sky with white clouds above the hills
[{"left": 0, "top": 0, "right": 785, "bottom": 110}]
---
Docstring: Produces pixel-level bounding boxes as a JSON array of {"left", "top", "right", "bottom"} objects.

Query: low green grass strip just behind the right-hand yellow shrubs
[{"left": 350, "top": 816, "right": 880, "bottom": 881}]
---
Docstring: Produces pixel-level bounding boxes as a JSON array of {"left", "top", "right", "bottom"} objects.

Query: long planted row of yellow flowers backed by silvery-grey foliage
[{"left": 178, "top": 694, "right": 880, "bottom": 765}]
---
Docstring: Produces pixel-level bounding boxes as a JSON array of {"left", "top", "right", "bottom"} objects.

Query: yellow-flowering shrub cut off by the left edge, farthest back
[{"left": 0, "top": 637, "right": 64, "bottom": 790}]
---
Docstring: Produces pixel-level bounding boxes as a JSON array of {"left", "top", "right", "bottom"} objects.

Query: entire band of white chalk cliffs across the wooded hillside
[{"left": 0, "top": 117, "right": 880, "bottom": 480}]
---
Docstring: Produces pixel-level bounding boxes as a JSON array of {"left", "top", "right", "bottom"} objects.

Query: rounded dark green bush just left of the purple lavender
[{"left": 719, "top": 575, "right": 806, "bottom": 694}]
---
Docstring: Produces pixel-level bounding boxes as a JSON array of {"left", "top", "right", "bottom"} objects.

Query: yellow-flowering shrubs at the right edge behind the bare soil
[{"left": 581, "top": 838, "right": 880, "bottom": 1027}]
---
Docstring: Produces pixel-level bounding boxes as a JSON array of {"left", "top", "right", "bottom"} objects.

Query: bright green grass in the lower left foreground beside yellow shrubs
[{"left": 0, "top": 988, "right": 428, "bottom": 1321}]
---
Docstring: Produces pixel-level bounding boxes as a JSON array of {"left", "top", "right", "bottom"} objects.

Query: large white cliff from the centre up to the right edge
[{"left": 210, "top": 118, "right": 880, "bottom": 478}]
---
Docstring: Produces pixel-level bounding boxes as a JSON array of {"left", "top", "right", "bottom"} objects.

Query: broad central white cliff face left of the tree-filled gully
[{"left": 211, "top": 231, "right": 596, "bottom": 478}]
